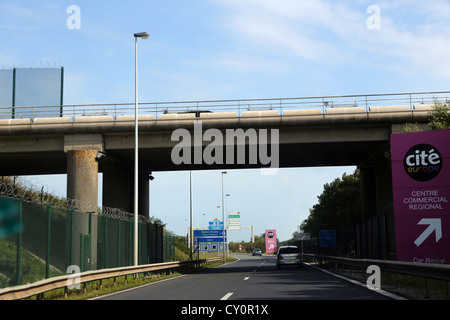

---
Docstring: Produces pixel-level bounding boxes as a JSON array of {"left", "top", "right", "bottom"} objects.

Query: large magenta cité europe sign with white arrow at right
[{"left": 391, "top": 130, "right": 450, "bottom": 263}]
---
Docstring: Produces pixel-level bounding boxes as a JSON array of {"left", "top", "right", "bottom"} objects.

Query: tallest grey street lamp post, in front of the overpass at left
[{"left": 134, "top": 32, "right": 149, "bottom": 266}]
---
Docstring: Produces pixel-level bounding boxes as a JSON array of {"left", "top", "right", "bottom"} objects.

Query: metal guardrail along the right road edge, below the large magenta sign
[{"left": 303, "top": 253, "right": 450, "bottom": 300}]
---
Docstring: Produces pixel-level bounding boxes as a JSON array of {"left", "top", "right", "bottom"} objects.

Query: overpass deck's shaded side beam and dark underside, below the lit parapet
[{"left": 0, "top": 127, "right": 390, "bottom": 176}]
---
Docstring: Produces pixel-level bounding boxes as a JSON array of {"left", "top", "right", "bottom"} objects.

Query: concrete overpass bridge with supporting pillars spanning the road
[{"left": 0, "top": 92, "right": 450, "bottom": 217}]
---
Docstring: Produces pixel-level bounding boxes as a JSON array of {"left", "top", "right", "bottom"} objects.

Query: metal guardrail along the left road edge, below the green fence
[{"left": 0, "top": 258, "right": 223, "bottom": 300}]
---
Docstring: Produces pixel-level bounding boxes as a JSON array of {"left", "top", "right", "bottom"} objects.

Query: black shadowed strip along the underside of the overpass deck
[{"left": 0, "top": 141, "right": 387, "bottom": 176}]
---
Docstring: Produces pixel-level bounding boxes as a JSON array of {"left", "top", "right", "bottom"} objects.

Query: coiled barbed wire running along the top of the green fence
[{"left": 0, "top": 177, "right": 152, "bottom": 225}]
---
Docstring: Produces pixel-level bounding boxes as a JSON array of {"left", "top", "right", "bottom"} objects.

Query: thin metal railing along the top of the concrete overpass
[{"left": 0, "top": 91, "right": 450, "bottom": 119}]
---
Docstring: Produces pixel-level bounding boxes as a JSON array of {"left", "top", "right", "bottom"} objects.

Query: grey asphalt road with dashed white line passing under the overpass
[{"left": 99, "top": 255, "right": 389, "bottom": 300}]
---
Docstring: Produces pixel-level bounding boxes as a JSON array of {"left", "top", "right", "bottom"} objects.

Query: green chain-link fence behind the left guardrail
[{"left": 0, "top": 197, "right": 175, "bottom": 288}]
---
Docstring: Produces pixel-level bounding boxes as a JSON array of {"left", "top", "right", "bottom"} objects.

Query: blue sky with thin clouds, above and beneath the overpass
[{"left": 0, "top": 0, "right": 450, "bottom": 240}]
